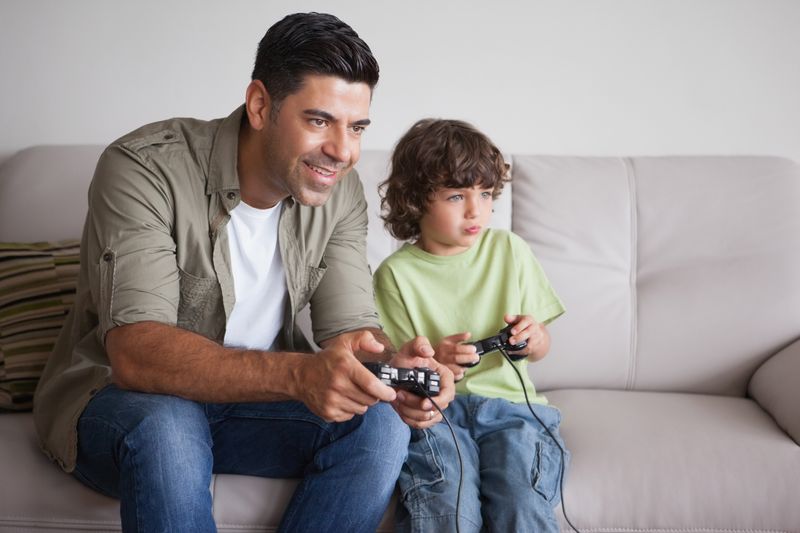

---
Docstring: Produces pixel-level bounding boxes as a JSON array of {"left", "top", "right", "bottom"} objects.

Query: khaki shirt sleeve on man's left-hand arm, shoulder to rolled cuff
[{"left": 85, "top": 141, "right": 179, "bottom": 343}]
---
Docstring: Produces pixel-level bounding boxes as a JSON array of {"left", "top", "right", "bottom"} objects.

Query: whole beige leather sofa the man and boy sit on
[{"left": 0, "top": 146, "right": 800, "bottom": 533}]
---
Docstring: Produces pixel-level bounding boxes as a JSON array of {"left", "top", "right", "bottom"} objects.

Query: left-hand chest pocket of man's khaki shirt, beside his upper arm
[{"left": 178, "top": 268, "right": 225, "bottom": 340}]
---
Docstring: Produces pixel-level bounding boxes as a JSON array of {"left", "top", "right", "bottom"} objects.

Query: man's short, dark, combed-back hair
[{"left": 252, "top": 13, "right": 379, "bottom": 117}]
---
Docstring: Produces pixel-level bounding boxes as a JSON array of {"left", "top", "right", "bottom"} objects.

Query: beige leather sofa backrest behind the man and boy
[{"left": 0, "top": 145, "right": 800, "bottom": 396}]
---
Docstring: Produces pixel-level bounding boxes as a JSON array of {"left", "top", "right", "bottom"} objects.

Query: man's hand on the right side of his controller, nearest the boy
[{"left": 389, "top": 337, "right": 456, "bottom": 429}]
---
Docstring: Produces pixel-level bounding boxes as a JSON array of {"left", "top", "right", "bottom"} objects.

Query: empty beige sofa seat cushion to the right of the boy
[{"left": 546, "top": 389, "right": 800, "bottom": 533}]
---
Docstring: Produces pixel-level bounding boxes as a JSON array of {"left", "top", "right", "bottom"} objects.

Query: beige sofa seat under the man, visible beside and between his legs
[{"left": 0, "top": 413, "right": 395, "bottom": 533}]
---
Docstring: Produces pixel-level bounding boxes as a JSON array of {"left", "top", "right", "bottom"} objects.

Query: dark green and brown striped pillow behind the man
[{"left": 0, "top": 240, "right": 80, "bottom": 411}]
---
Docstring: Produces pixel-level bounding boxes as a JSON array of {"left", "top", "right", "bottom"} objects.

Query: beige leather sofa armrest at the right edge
[{"left": 748, "top": 340, "right": 800, "bottom": 444}]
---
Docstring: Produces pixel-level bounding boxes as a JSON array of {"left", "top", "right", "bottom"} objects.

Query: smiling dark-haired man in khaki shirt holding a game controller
[{"left": 34, "top": 13, "right": 453, "bottom": 532}]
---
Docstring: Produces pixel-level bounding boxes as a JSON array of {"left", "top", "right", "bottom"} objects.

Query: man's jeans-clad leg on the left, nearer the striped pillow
[{"left": 75, "top": 385, "right": 216, "bottom": 532}]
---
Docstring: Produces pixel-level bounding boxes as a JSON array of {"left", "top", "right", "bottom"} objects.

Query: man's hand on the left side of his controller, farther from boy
[{"left": 294, "top": 331, "right": 397, "bottom": 422}]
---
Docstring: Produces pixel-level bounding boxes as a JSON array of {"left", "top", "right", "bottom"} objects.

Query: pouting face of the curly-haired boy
[{"left": 416, "top": 186, "right": 492, "bottom": 255}]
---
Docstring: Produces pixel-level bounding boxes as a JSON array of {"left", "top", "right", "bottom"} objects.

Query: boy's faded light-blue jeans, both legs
[{"left": 397, "top": 395, "right": 569, "bottom": 533}]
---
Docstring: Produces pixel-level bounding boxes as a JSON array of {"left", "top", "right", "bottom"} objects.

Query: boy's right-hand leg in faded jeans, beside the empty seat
[{"left": 475, "top": 399, "right": 566, "bottom": 533}]
